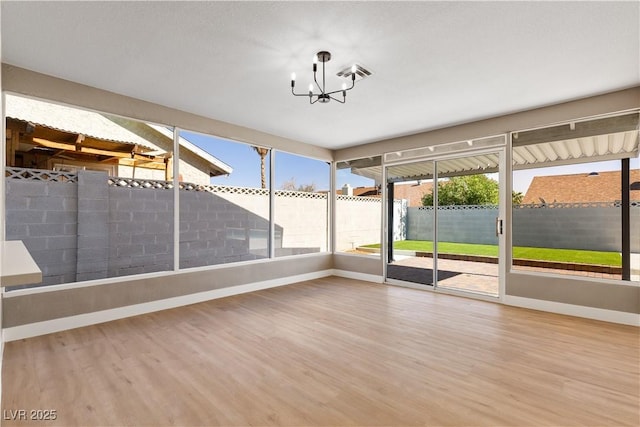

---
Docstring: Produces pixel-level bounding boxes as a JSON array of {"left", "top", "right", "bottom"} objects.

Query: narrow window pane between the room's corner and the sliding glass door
[{"left": 335, "top": 156, "right": 382, "bottom": 257}]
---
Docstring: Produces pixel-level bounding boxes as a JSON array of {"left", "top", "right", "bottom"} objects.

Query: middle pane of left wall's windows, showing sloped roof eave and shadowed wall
[{"left": 179, "top": 131, "right": 271, "bottom": 268}]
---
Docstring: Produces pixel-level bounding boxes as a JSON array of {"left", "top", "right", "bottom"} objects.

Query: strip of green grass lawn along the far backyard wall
[{"left": 365, "top": 240, "right": 622, "bottom": 267}]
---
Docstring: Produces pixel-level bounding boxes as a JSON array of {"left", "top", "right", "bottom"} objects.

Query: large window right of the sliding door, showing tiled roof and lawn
[{"left": 512, "top": 114, "right": 640, "bottom": 281}]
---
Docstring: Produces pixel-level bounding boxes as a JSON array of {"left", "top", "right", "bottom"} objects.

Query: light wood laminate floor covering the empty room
[{"left": 2, "top": 277, "right": 640, "bottom": 426}]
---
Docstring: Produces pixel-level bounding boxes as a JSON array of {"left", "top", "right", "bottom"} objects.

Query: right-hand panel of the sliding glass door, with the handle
[{"left": 434, "top": 152, "right": 502, "bottom": 297}]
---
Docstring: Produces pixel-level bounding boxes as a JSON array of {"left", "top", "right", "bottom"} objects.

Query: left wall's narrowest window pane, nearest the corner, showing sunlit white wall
[{"left": 274, "top": 152, "right": 330, "bottom": 257}]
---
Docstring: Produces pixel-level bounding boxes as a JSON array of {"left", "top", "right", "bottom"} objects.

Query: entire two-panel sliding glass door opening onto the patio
[{"left": 385, "top": 142, "right": 506, "bottom": 297}]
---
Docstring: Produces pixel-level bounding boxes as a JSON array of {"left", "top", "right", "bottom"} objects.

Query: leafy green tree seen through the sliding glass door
[{"left": 422, "top": 175, "right": 498, "bottom": 206}]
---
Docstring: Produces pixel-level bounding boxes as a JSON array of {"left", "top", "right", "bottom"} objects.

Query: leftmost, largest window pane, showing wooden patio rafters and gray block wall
[{"left": 5, "top": 95, "right": 173, "bottom": 285}]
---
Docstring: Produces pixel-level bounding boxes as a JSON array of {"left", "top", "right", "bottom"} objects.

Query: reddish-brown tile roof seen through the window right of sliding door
[{"left": 522, "top": 169, "right": 640, "bottom": 204}]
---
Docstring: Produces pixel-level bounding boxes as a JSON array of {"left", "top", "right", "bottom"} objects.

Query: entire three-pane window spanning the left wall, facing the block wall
[{"left": 5, "top": 94, "right": 330, "bottom": 290}]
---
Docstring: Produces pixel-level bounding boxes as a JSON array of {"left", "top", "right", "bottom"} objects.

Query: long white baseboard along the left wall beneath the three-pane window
[{"left": 3, "top": 270, "right": 334, "bottom": 342}]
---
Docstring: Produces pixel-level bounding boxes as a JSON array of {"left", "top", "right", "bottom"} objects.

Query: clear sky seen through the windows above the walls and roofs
[{"left": 181, "top": 131, "right": 640, "bottom": 194}]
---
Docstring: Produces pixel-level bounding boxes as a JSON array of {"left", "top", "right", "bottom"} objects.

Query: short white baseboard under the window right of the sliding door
[{"left": 504, "top": 295, "right": 640, "bottom": 326}]
